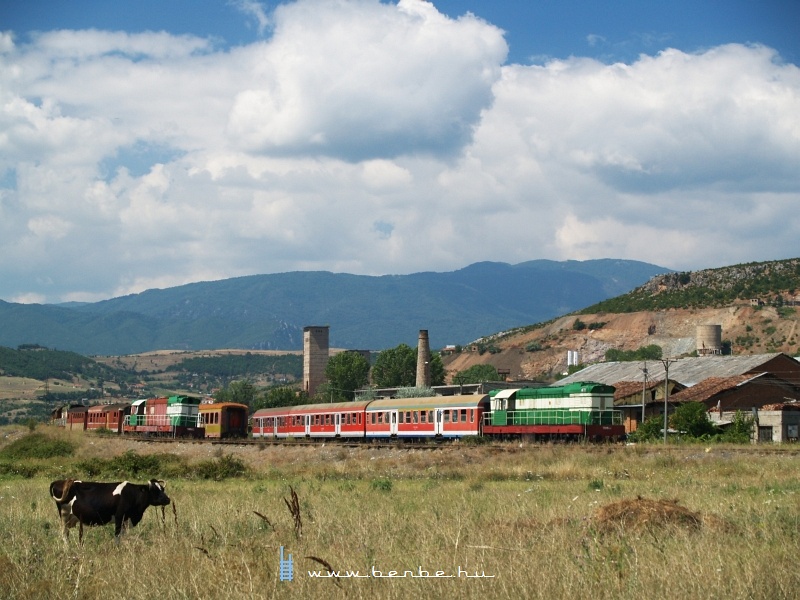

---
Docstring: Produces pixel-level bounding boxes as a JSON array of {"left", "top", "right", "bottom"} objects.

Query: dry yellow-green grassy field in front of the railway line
[{"left": 0, "top": 428, "right": 800, "bottom": 600}]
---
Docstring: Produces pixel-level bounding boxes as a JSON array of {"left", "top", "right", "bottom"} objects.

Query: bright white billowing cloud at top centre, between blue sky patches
[{"left": 223, "top": 0, "right": 508, "bottom": 160}]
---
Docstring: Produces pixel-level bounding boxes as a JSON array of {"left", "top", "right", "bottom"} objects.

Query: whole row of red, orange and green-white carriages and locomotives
[{"left": 54, "top": 382, "right": 625, "bottom": 441}]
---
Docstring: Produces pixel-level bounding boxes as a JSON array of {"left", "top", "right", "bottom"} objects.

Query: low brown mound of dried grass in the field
[{"left": 595, "top": 496, "right": 703, "bottom": 531}]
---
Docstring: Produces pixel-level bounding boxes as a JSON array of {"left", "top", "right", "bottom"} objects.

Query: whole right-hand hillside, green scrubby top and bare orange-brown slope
[{"left": 444, "top": 259, "right": 800, "bottom": 379}]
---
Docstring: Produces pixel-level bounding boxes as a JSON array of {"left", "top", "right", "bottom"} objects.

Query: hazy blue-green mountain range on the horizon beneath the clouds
[{"left": 0, "top": 259, "right": 670, "bottom": 355}]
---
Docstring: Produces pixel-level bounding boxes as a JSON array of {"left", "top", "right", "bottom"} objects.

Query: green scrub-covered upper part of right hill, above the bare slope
[{"left": 579, "top": 258, "right": 800, "bottom": 314}]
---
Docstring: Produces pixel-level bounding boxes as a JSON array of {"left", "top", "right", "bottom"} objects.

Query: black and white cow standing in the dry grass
[{"left": 50, "top": 479, "right": 170, "bottom": 542}]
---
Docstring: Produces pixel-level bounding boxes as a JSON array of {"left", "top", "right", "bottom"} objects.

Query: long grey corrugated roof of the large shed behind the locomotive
[{"left": 559, "top": 352, "right": 790, "bottom": 387}]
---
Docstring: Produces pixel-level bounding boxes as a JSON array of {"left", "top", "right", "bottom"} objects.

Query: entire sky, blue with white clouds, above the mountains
[{"left": 0, "top": 0, "right": 800, "bottom": 303}]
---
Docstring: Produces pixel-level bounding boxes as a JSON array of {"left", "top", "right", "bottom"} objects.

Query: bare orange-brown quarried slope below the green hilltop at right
[{"left": 444, "top": 304, "right": 800, "bottom": 380}]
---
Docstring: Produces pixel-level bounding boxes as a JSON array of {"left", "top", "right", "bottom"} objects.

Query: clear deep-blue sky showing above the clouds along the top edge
[{"left": 0, "top": 0, "right": 800, "bottom": 63}]
